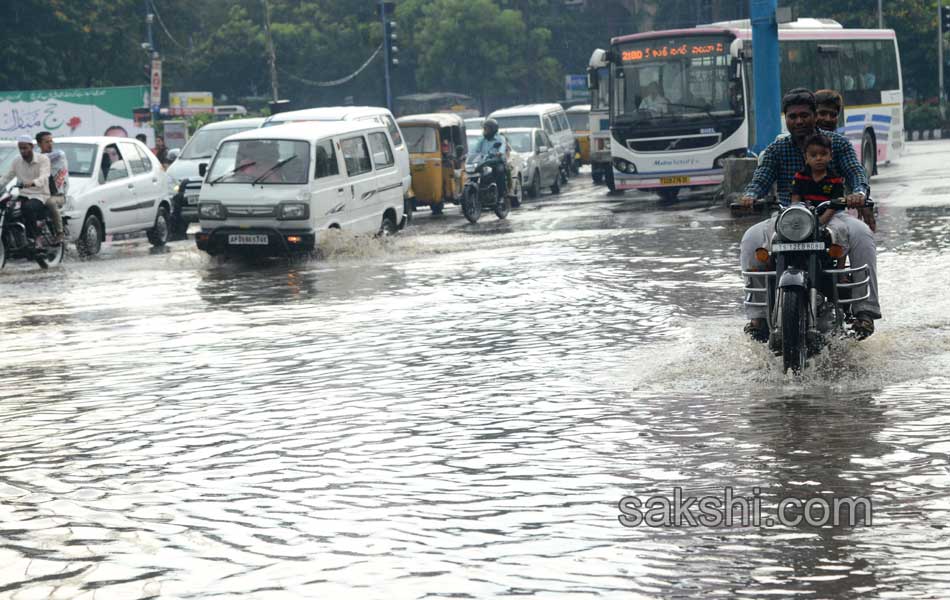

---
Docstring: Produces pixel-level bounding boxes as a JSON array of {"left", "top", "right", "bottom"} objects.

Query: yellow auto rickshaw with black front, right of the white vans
[{"left": 397, "top": 113, "right": 468, "bottom": 215}]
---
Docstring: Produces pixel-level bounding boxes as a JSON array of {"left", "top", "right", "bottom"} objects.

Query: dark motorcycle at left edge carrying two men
[{"left": 0, "top": 188, "right": 66, "bottom": 269}]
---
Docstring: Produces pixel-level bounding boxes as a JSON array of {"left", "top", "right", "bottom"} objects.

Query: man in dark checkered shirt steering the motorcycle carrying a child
[{"left": 739, "top": 88, "right": 881, "bottom": 341}]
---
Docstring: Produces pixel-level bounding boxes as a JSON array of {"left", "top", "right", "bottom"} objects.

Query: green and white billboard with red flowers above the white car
[{"left": 0, "top": 85, "right": 154, "bottom": 143}]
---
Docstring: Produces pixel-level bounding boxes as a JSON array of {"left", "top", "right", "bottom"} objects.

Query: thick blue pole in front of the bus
[{"left": 750, "top": 0, "right": 782, "bottom": 153}]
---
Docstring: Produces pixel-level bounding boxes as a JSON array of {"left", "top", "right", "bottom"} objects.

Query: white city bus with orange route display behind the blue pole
[{"left": 606, "top": 19, "right": 904, "bottom": 201}]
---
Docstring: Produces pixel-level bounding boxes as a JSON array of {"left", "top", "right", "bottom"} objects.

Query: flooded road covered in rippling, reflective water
[{"left": 0, "top": 142, "right": 950, "bottom": 599}]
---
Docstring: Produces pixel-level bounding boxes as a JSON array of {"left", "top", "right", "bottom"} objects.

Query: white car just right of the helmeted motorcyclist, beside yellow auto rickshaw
[{"left": 500, "top": 127, "right": 561, "bottom": 198}]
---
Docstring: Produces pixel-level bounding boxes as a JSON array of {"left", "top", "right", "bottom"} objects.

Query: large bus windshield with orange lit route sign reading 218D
[{"left": 613, "top": 36, "right": 742, "bottom": 122}]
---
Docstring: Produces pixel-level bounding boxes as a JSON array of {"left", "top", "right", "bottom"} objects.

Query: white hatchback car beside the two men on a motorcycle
[{"left": 54, "top": 137, "right": 171, "bottom": 256}]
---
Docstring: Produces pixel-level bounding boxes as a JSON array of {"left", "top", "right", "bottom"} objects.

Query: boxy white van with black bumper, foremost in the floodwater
[{"left": 195, "top": 121, "right": 403, "bottom": 255}]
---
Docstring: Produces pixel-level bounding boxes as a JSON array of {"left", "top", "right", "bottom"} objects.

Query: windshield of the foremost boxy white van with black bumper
[{"left": 207, "top": 139, "right": 310, "bottom": 185}]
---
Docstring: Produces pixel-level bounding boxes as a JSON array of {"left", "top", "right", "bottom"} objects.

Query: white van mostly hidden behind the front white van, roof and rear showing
[{"left": 262, "top": 106, "right": 413, "bottom": 229}]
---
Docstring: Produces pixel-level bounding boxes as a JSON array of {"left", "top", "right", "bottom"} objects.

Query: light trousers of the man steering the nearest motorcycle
[{"left": 739, "top": 211, "right": 881, "bottom": 319}]
